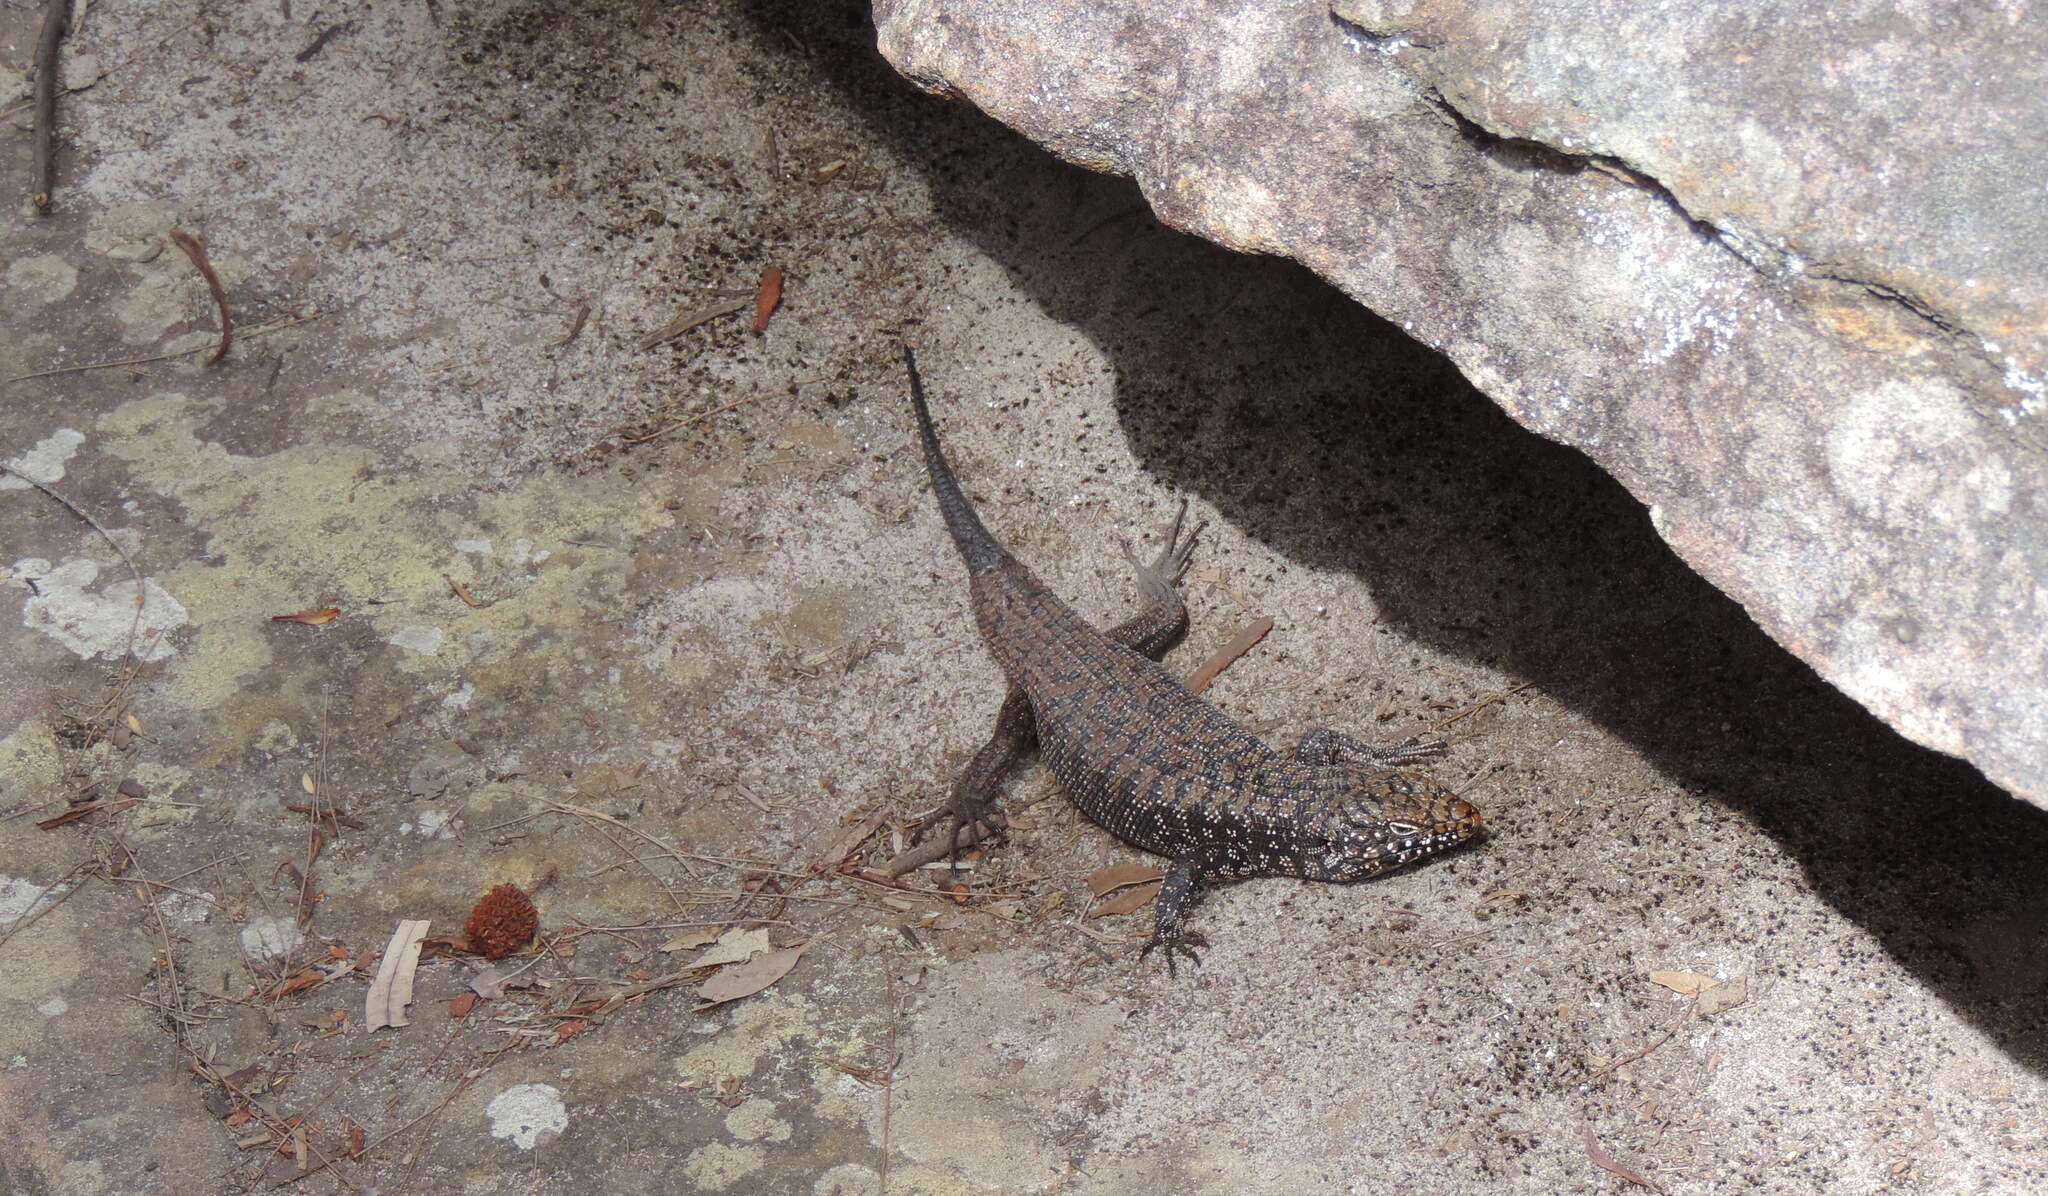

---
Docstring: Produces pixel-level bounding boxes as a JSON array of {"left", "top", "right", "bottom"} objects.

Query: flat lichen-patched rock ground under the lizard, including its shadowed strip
[{"left": 0, "top": 0, "right": 2048, "bottom": 1196}]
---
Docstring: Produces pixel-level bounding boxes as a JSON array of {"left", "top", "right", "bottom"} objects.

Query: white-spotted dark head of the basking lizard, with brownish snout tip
[{"left": 1305, "top": 770, "right": 1481, "bottom": 883}]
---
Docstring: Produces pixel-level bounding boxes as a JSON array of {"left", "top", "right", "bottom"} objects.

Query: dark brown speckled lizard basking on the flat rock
[{"left": 903, "top": 346, "right": 1481, "bottom": 971}]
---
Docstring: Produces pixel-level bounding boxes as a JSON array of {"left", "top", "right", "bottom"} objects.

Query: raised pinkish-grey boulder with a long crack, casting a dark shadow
[{"left": 877, "top": 0, "right": 2048, "bottom": 803}]
